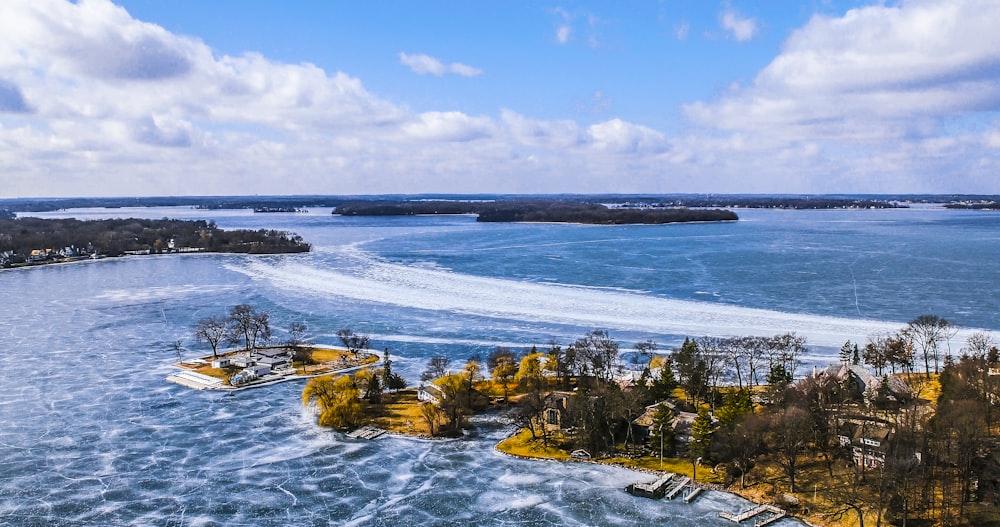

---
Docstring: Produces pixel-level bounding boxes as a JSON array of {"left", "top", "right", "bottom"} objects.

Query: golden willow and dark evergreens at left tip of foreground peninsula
[{"left": 302, "top": 349, "right": 406, "bottom": 430}]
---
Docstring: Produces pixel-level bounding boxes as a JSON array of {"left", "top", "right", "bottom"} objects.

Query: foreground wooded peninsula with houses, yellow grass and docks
[{"left": 303, "top": 330, "right": 1000, "bottom": 526}]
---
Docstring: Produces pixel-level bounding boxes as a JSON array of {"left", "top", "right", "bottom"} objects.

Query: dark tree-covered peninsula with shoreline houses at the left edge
[{"left": 0, "top": 217, "right": 310, "bottom": 262}]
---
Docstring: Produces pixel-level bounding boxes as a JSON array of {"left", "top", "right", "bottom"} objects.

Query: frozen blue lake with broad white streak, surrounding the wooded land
[{"left": 0, "top": 208, "right": 1000, "bottom": 526}]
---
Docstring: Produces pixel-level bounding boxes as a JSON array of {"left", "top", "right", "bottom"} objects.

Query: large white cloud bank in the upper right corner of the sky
[{"left": 685, "top": 0, "right": 1000, "bottom": 137}]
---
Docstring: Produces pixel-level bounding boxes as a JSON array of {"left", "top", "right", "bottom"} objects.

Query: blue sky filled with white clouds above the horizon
[{"left": 0, "top": 0, "right": 1000, "bottom": 197}]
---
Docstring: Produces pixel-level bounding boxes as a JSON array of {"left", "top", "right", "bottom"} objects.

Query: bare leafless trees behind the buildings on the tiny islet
[{"left": 194, "top": 304, "right": 274, "bottom": 357}]
